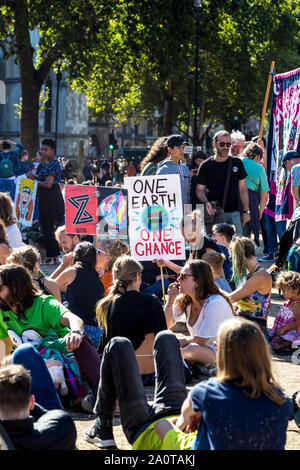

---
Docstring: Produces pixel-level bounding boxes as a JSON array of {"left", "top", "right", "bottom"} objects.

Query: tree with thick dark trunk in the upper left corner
[{"left": 0, "top": 0, "right": 113, "bottom": 155}]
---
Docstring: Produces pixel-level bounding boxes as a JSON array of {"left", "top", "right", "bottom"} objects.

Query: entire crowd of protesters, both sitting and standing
[{"left": 0, "top": 130, "right": 300, "bottom": 450}]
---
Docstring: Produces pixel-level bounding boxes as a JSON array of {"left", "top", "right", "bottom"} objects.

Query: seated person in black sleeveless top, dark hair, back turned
[{"left": 55, "top": 242, "right": 104, "bottom": 348}]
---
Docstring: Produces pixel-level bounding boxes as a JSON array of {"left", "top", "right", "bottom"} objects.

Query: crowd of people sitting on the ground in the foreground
[{"left": 0, "top": 208, "right": 300, "bottom": 450}]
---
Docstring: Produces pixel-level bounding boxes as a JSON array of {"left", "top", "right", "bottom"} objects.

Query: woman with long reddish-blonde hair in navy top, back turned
[{"left": 172, "top": 318, "right": 294, "bottom": 450}]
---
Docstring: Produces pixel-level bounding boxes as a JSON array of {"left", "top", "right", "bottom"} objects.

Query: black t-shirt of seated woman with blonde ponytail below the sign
[{"left": 99, "top": 290, "right": 167, "bottom": 353}]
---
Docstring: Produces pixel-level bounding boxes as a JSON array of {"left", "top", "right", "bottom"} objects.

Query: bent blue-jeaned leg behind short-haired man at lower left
[{"left": 12, "top": 343, "right": 63, "bottom": 410}]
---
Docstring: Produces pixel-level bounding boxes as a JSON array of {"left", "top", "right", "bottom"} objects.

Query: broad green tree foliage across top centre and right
[{"left": 73, "top": 0, "right": 299, "bottom": 140}]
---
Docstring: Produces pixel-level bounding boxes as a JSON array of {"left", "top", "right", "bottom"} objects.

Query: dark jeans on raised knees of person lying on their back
[{"left": 94, "top": 330, "right": 187, "bottom": 444}]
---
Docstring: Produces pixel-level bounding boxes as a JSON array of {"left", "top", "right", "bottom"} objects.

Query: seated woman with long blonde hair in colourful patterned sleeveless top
[{"left": 229, "top": 235, "right": 272, "bottom": 332}]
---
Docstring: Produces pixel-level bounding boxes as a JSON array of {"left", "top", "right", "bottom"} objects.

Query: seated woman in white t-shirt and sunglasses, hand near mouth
[{"left": 165, "top": 260, "right": 233, "bottom": 375}]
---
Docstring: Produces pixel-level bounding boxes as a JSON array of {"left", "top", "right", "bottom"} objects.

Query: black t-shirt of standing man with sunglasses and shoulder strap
[{"left": 197, "top": 157, "right": 247, "bottom": 212}]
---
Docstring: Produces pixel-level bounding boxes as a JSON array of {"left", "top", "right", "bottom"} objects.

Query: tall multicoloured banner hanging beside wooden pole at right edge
[{"left": 265, "top": 68, "right": 300, "bottom": 221}]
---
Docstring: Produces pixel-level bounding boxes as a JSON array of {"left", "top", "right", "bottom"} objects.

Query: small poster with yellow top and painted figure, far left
[{"left": 14, "top": 175, "right": 38, "bottom": 227}]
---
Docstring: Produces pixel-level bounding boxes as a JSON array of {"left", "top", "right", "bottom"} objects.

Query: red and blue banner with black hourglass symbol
[{"left": 65, "top": 185, "right": 127, "bottom": 238}]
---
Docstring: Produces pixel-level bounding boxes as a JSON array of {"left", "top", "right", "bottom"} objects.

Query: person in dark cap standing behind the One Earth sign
[{"left": 156, "top": 134, "right": 191, "bottom": 206}]
